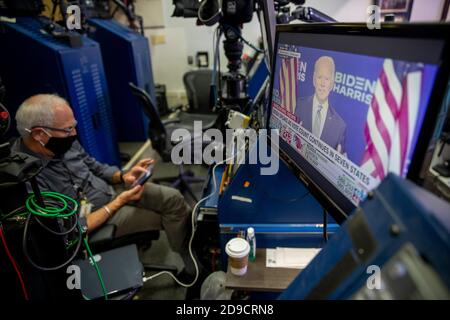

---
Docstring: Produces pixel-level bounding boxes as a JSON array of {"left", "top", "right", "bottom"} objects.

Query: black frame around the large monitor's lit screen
[{"left": 266, "top": 23, "right": 450, "bottom": 223}]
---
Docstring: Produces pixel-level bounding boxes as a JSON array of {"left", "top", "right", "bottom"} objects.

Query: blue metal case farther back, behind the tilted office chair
[{"left": 87, "top": 19, "right": 156, "bottom": 141}]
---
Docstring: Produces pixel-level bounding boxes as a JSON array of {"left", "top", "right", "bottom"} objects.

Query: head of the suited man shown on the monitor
[{"left": 314, "top": 56, "right": 335, "bottom": 103}]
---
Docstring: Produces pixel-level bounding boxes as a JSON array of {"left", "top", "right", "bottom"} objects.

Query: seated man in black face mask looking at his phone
[{"left": 13, "top": 94, "right": 195, "bottom": 278}]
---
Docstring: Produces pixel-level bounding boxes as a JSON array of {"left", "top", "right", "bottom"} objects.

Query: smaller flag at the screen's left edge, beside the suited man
[{"left": 280, "top": 57, "right": 298, "bottom": 113}]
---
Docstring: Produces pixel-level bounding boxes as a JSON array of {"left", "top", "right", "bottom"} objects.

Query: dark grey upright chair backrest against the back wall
[{"left": 183, "top": 69, "right": 213, "bottom": 114}]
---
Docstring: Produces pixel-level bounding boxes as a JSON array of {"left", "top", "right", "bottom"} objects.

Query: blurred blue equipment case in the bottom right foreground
[{"left": 280, "top": 174, "right": 450, "bottom": 299}]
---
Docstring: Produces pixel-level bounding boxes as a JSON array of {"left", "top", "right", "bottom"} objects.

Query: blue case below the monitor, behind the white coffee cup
[{"left": 218, "top": 140, "right": 339, "bottom": 266}]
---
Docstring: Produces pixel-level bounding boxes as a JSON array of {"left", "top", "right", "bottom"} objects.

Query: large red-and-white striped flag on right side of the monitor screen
[{"left": 361, "top": 59, "right": 423, "bottom": 180}]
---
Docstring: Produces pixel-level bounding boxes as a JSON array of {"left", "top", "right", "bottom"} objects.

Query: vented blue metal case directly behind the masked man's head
[{"left": 0, "top": 17, "right": 120, "bottom": 165}]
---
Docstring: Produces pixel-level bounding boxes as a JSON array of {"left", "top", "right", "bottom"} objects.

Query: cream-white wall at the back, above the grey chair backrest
[{"left": 136, "top": 0, "right": 260, "bottom": 104}]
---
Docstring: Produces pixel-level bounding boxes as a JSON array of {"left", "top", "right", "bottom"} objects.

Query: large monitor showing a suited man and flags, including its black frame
[{"left": 268, "top": 25, "right": 448, "bottom": 221}]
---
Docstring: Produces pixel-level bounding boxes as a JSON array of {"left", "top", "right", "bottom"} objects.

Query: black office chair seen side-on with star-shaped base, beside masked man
[{"left": 129, "top": 82, "right": 216, "bottom": 202}]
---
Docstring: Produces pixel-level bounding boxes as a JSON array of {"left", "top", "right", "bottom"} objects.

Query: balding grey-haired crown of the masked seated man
[{"left": 16, "top": 94, "right": 74, "bottom": 137}]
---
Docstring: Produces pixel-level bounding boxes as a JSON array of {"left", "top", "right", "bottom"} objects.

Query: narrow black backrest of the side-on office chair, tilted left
[{"left": 128, "top": 82, "right": 167, "bottom": 154}]
